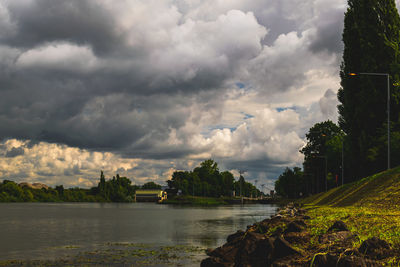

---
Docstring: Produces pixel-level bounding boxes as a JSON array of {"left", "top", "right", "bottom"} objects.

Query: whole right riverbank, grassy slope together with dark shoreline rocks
[{"left": 202, "top": 168, "right": 400, "bottom": 266}]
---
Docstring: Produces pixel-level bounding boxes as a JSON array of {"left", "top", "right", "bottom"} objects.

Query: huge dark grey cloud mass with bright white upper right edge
[{"left": 0, "top": 0, "right": 265, "bottom": 158}]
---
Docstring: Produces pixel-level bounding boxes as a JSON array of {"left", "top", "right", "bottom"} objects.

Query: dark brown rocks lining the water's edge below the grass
[{"left": 201, "top": 204, "right": 400, "bottom": 267}]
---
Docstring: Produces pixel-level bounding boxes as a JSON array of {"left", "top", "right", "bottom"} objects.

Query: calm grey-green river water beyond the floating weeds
[{"left": 0, "top": 203, "right": 277, "bottom": 260}]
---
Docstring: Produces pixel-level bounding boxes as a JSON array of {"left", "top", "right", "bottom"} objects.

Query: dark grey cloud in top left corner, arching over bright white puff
[{"left": 0, "top": 0, "right": 121, "bottom": 53}]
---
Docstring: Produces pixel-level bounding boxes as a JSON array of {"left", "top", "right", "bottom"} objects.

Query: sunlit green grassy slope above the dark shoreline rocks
[{"left": 301, "top": 167, "right": 400, "bottom": 263}]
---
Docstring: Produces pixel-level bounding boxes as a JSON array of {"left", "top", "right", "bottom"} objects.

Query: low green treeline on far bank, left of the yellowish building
[{"left": 0, "top": 171, "right": 161, "bottom": 202}]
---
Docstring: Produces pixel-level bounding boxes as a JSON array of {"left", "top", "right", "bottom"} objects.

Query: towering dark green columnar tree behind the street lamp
[{"left": 338, "top": 0, "right": 400, "bottom": 179}]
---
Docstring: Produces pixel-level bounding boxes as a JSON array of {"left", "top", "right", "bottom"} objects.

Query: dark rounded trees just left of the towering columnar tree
[{"left": 275, "top": 120, "right": 345, "bottom": 198}]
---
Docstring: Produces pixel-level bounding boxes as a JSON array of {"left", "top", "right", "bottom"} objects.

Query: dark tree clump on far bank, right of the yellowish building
[{"left": 167, "top": 159, "right": 261, "bottom": 197}]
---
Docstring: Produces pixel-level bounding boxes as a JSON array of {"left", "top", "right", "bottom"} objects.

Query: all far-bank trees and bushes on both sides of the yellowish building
[{"left": 0, "top": 159, "right": 261, "bottom": 205}]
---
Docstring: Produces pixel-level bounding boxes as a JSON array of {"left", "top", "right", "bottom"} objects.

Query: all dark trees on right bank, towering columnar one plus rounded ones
[{"left": 275, "top": 0, "right": 400, "bottom": 198}]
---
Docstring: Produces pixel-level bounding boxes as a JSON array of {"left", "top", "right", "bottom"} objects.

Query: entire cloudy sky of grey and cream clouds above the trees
[{"left": 0, "top": 0, "right": 396, "bottom": 193}]
